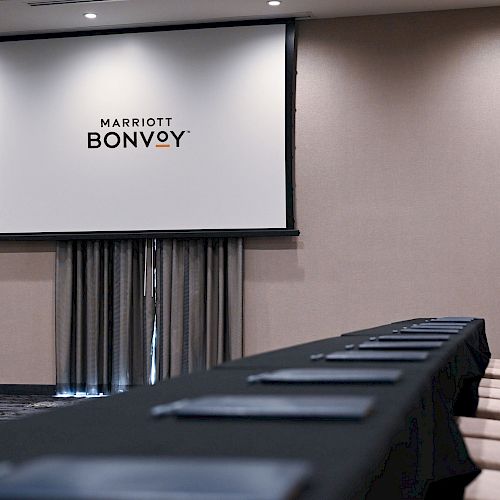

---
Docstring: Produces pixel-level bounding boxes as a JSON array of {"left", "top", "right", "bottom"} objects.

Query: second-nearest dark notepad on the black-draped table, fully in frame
[{"left": 151, "top": 394, "right": 374, "bottom": 420}]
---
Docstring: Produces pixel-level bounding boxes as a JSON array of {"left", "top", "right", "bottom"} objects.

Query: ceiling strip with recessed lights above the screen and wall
[{"left": 0, "top": 0, "right": 500, "bottom": 35}]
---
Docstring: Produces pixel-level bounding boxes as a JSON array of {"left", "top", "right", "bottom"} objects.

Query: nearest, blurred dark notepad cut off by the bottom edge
[{"left": 0, "top": 456, "right": 311, "bottom": 500}]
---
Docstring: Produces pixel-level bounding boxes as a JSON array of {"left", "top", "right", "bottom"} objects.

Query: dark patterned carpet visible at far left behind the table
[{"left": 0, "top": 394, "right": 85, "bottom": 422}]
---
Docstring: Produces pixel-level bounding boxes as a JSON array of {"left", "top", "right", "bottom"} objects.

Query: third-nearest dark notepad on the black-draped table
[{"left": 247, "top": 368, "right": 402, "bottom": 384}]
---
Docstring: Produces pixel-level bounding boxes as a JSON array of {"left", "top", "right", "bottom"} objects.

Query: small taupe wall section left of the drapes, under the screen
[{"left": 0, "top": 242, "right": 55, "bottom": 385}]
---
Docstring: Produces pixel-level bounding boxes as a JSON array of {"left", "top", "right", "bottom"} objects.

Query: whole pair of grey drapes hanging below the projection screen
[{"left": 56, "top": 238, "right": 243, "bottom": 395}]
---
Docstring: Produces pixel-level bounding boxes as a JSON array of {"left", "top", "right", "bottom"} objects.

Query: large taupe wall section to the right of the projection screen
[{"left": 245, "top": 9, "right": 500, "bottom": 356}]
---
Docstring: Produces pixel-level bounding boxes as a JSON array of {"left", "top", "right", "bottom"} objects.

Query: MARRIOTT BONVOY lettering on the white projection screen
[{"left": 87, "top": 117, "right": 191, "bottom": 149}]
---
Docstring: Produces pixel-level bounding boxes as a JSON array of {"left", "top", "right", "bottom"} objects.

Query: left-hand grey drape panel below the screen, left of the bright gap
[{"left": 56, "top": 240, "right": 154, "bottom": 394}]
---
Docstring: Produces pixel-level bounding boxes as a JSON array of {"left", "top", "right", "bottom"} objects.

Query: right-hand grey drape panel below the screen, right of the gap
[{"left": 156, "top": 238, "right": 243, "bottom": 380}]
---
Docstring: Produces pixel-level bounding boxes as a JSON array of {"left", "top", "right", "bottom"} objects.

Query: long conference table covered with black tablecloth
[{"left": 0, "top": 318, "right": 490, "bottom": 500}]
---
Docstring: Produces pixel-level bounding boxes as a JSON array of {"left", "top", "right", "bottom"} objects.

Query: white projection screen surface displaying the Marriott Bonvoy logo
[{"left": 0, "top": 24, "right": 287, "bottom": 236}]
